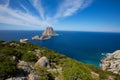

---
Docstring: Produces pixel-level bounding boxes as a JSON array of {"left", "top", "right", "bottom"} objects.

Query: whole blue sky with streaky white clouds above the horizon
[{"left": 0, "top": 0, "right": 120, "bottom": 32}]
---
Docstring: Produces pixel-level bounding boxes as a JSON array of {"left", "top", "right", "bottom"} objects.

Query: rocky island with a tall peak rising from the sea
[{"left": 32, "top": 27, "right": 58, "bottom": 40}]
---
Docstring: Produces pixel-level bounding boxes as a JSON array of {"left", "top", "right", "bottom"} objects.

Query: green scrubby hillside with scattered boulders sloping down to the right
[{"left": 0, "top": 41, "right": 120, "bottom": 80}]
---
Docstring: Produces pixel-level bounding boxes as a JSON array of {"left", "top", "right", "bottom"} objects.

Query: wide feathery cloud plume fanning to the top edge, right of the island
[{"left": 55, "top": 0, "right": 92, "bottom": 18}]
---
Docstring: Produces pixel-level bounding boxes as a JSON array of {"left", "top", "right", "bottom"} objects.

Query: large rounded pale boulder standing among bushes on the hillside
[{"left": 35, "top": 56, "right": 50, "bottom": 67}]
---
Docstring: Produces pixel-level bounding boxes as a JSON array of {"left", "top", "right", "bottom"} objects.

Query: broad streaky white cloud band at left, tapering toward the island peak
[{"left": 0, "top": 0, "right": 48, "bottom": 26}]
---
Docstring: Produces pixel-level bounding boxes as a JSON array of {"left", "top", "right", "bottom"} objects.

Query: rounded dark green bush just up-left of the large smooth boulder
[{"left": 22, "top": 52, "right": 38, "bottom": 62}]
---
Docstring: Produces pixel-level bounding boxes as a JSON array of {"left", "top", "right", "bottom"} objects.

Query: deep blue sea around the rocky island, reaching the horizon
[{"left": 0, "top": 30, "right": 120, "bottom": 66}]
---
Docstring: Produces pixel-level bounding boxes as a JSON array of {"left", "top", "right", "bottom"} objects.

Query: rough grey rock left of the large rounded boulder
[{"left": 17, "top": 61, "right": 34, "bottom": 74}]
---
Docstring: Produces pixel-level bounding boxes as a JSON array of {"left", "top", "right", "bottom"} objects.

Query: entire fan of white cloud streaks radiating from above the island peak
[{"left": 0, "top": 0, "right": 92, "bottom": 27}]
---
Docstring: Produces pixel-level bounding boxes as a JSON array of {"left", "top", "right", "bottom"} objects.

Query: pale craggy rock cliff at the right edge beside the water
[{"left": 101, "top": 50, "right": 120, "bottom": 75}]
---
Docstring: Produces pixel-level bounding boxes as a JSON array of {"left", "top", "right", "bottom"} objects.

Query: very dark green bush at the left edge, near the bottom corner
[{"left": 0, "top": 56, "right": 18, "bottom": 79}]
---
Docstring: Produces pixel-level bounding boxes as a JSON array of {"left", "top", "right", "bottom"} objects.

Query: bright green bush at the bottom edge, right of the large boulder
[{"left": 63, "top": 61, "right": 94, "bottom": 80}]
